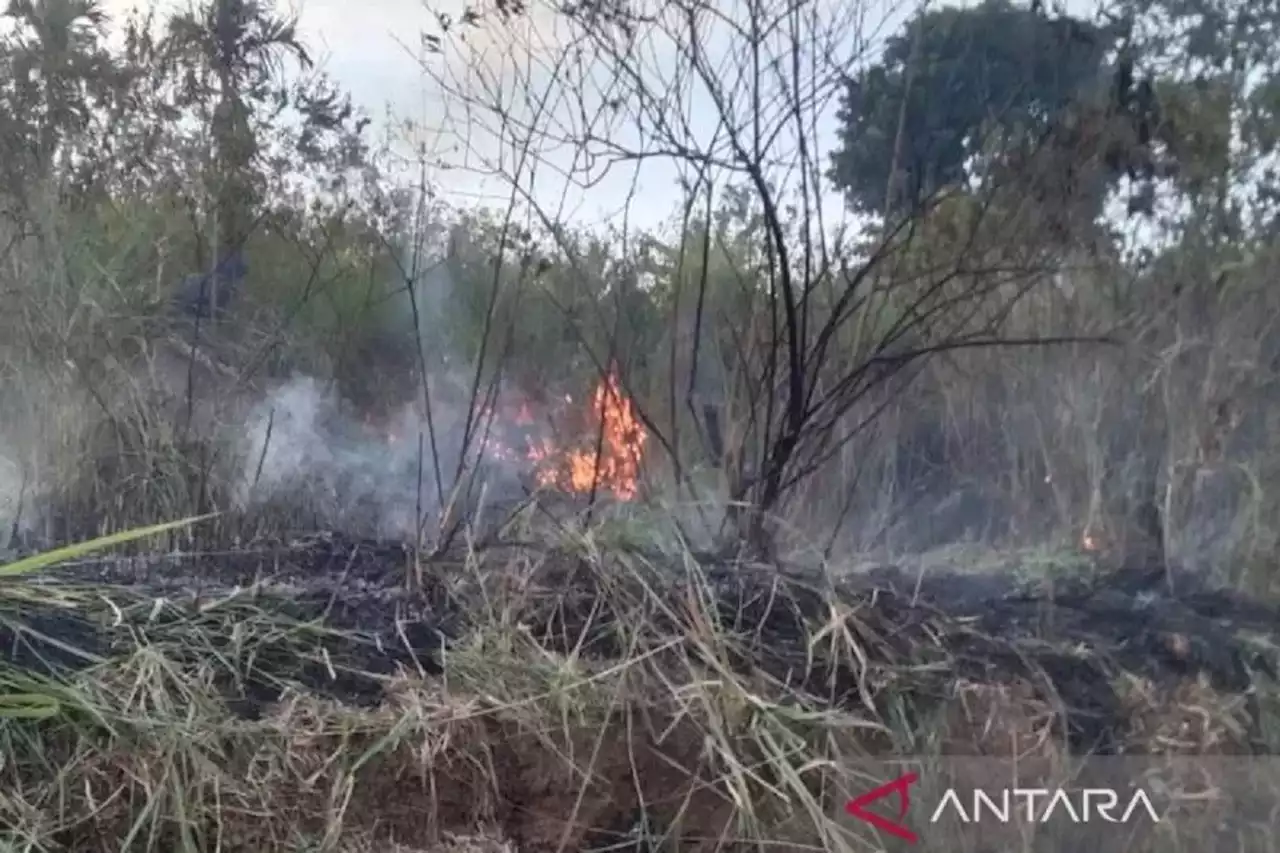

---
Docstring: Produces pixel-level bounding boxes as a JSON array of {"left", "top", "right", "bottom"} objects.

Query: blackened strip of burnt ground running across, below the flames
[{"left": 10, "top": 533, "right": 1280, "bottom": 752}]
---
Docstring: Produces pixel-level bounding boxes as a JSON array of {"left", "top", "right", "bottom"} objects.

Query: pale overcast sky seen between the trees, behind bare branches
[{"left": 104, "top": 0, "right": 1084, "bottom": 233}]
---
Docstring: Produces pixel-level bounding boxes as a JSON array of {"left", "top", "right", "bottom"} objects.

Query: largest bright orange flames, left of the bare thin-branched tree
[{"left": 529, "top": 373, "right": 649, "bottom": 501}]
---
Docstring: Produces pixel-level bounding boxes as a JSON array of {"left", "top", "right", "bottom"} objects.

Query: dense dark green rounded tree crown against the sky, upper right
[{"left": 829, "top": 0, "right": 1114, "bottom": 214}]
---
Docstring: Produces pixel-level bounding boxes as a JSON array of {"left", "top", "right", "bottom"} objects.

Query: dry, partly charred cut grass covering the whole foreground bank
[{"left": 0, "top": 522, "right": 1275, "bottom": 853}]
